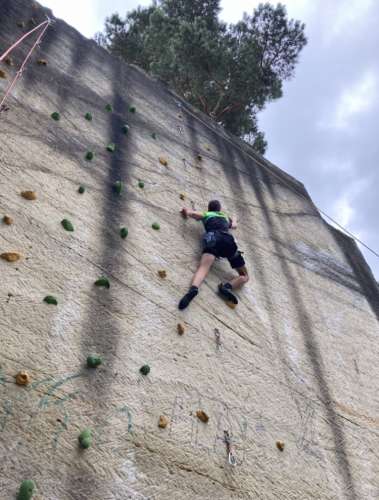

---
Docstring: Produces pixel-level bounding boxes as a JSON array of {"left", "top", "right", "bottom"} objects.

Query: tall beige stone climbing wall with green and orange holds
[{"left": 0, "top": 0, "right": 379, "bottom": 500}]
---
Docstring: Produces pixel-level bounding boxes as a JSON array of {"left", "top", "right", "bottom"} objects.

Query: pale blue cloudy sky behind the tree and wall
[{"left": 40, "top": 0, "right": 379, "bottom": 280}]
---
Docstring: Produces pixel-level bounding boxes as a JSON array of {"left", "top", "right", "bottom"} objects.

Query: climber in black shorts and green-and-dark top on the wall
[{"left": 179, "top": 200, "right": 249, "bottom": 309}]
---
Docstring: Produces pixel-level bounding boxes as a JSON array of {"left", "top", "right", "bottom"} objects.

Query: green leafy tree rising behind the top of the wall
[{"left": 97, "top": 0, "right": 307, "bottom": 153}]
